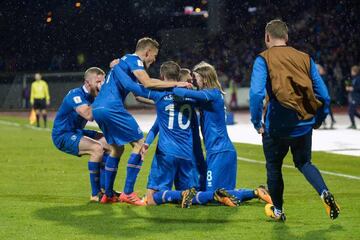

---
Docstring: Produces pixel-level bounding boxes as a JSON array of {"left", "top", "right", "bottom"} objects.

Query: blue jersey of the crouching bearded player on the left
[{"left": 52, "top": 86, "right": 94, "bottom": 136}]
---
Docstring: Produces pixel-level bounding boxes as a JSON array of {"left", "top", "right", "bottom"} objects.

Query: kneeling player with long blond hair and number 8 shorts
[{"left": 173, "top": 62, "right": 271, "bottom": 206}]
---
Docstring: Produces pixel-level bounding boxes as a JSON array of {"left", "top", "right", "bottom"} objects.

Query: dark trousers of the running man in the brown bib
[{"left": 263, "top": 131, "right": 327, "bottom": 210}]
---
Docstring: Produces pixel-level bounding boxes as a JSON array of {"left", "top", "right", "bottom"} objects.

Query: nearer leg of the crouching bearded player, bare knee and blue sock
[{"left": 79, "top": 136, "right": 104, "bottom": 200}]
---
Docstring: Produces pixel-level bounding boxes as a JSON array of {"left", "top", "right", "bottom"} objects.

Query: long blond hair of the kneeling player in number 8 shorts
[{"left": 193, "top": 61, "right": 225, "bottom": 94}]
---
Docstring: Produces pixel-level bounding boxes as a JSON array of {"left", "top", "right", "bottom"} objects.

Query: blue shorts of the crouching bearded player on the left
[{"left": 52, "top": 129, "right": 98, "bottom": 157}]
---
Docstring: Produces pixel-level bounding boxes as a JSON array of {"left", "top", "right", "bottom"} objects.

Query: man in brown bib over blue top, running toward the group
[{"left": 250, "top": 20, "right": 340, "bottom": 221}]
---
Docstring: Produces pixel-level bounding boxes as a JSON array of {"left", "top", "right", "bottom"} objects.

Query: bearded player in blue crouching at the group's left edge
[{"left": 52, "top": 67, "right": 109, "bottom": 201}]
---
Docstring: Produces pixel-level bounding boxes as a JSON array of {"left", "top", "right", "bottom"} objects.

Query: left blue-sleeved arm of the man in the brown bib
[{"left": 249, "top": 57, "right": 268, "bottom": 133}]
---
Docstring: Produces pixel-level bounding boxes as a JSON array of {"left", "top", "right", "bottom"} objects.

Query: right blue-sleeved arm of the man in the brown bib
[{"left": 310, "top": 59, "right": 330, "bottom": 129}]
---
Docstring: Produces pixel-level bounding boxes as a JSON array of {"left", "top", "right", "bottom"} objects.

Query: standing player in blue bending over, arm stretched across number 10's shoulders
[{"left": 93, "top": 38, "right": 191, "bottom": 205}]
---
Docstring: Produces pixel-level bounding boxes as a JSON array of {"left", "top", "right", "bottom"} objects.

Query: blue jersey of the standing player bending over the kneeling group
[{"left": 93, "top": 54, "right": 145, "bottom": 108}]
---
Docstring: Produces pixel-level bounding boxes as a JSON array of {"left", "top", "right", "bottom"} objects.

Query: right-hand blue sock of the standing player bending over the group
[{"left": 124, "top": 153, "right": 142, "bottom": 194}]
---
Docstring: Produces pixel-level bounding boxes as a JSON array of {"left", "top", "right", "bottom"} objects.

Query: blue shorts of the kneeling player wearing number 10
[{"left": 147, "top": 149, "right": 199, "bottom": 191}]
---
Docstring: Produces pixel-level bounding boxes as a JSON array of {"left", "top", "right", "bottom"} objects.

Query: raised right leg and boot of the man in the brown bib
[{"left": 290, "top": 131, "right": 340, "bottom": 219}]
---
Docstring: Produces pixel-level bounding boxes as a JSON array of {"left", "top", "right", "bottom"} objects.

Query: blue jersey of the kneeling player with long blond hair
[{"left": 173, "top": 88, "right": 234, "bottom": 155}]
